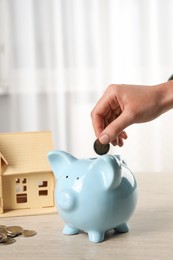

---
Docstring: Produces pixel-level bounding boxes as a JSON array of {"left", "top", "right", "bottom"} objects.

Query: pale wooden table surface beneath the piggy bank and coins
[{"left": 0, "top": 173, "right": 173, "bottom": 260}]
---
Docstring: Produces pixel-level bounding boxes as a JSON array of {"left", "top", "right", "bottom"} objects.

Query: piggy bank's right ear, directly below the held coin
[{"left": 93, "top": 155, "right": 121, "bottom": 189}]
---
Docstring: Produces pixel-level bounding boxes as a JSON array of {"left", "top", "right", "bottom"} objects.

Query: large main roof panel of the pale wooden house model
[{"left": 0, "top": 131, "right": 53, "bottom": 175}]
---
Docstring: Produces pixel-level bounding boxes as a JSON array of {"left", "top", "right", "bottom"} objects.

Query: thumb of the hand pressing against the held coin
[{"left": 99, "top": 112, "right": 132, "bottom": 144}]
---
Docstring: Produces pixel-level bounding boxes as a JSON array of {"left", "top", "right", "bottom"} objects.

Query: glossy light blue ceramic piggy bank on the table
[{"left": 48, "top": 151, "right": 137, "bottom": 242}]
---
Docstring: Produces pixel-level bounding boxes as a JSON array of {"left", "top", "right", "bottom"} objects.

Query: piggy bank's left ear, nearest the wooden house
[{"left": 48, "top": 150, "right": 77, "bottom": 179}]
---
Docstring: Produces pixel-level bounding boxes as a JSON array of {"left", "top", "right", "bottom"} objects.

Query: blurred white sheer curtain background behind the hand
[{"left": 0, "top": 0, "right": 173, "bottom": 172}]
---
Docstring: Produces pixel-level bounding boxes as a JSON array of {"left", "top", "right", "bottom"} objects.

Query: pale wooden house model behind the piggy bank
[{"left": 0, "top": 131, "right": 55, "bottom": 217}]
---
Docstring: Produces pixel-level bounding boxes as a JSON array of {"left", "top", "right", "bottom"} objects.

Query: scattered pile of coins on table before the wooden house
[{"left": 0, "top": 225, "right": 37, "bottom": 245}]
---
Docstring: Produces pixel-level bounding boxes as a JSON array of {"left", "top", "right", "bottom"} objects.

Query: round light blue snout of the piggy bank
[{"left": 57, "top": 190, "right": 76, "bottom": 211}]
